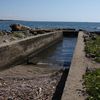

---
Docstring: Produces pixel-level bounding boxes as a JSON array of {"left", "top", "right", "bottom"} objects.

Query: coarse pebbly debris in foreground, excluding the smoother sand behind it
[{"left": 0, "top": 74, "right": 60, "bottom": 100}]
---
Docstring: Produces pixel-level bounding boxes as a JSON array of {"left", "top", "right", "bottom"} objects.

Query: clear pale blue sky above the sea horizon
[{"left": 0, "top": 0, "right": 100, "bottom": 22}]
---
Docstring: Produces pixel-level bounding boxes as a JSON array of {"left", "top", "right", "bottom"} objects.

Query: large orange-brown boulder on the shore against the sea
[{"left": 10, "top": 24, "right": 31, "bottom": 31}]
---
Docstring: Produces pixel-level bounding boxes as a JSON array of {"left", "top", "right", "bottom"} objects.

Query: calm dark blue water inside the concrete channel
[{"left": 29, "top": 37, "right": 77, "bottom": 67}]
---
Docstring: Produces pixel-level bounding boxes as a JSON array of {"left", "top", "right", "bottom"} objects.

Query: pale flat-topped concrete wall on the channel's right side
[{"left": 62, "top": 31, "right": 86, "bottom": 100}]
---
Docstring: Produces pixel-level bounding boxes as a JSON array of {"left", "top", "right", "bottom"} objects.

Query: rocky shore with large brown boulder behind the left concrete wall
[{"left": 0, "top": 24, "right": 53, "bottom": 44}]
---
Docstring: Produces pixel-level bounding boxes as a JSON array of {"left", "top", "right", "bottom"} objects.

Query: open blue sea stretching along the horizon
[{"left": 0, "top": 20, "right": 100, "bottom": 31}]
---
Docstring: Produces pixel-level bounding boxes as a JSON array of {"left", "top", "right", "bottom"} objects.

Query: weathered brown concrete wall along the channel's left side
[{"left": 0, "top": 31, "right": 63, "bottom": 69}]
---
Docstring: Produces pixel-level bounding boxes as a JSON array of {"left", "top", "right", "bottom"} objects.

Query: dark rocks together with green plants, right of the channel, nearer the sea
[{"left": 83, "top": 33, "right": 100, "bottom": 63}]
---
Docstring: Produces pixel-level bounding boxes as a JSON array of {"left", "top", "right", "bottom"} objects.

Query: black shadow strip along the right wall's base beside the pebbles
[{"left": 52, "top": 69, "right": 69, "bottom": 100}]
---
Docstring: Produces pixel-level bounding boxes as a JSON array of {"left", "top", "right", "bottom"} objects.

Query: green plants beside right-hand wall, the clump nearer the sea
[{"left": 85, "top": 35, "right": 100, "bottom": 62}]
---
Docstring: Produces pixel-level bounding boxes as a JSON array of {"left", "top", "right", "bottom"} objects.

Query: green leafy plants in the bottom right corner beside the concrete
[{"left": 83, "top": 69, "right": 100, "bottom": 100}]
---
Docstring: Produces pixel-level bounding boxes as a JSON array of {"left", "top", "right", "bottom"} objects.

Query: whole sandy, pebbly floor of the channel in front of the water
[{"left": 0, "top": 65, "right": 62, "bottom": 100}]
